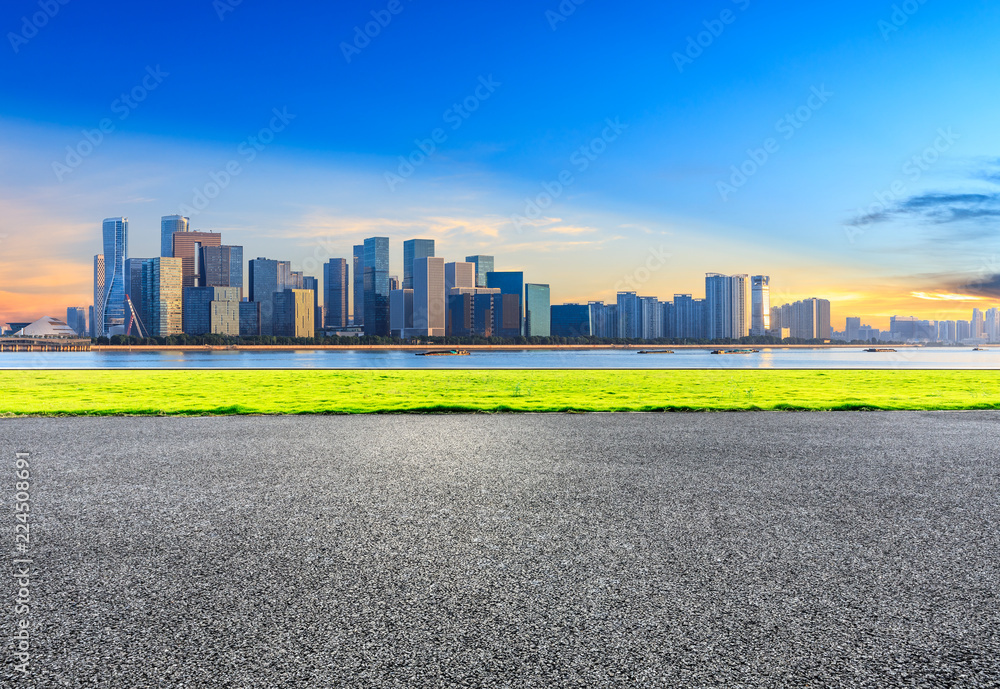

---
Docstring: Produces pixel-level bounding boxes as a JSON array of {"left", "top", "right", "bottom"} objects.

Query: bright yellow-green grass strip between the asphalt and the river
[{"left": 0, "top": 370, "right": 1000, "bottom": 416}]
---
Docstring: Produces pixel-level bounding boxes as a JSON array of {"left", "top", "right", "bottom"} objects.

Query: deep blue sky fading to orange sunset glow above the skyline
[{"left": 0, "top": 0, "right": 1000, "bottom": 327}]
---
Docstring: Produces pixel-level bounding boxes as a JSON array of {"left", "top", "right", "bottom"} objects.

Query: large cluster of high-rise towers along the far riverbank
[{"left": 7, "top": 215, "right": 852, "bottom": 340}]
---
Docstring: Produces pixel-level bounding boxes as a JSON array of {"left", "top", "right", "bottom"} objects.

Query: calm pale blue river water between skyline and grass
[{"left": 0, "top": 346, "right": 1000, "bottom": 369}]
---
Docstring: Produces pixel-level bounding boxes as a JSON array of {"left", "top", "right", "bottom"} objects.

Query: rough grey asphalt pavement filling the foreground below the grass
[{"left": 0, "top": 413, "right": 1000, "bottom": 688}]
